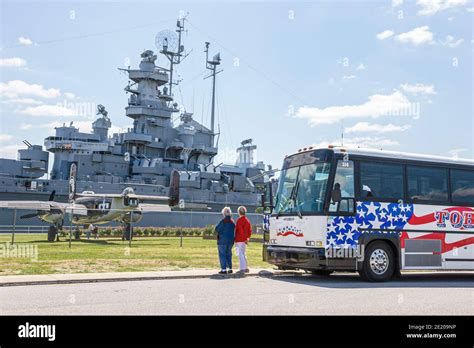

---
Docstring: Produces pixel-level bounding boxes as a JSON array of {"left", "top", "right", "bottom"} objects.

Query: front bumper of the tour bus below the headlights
[{"left": 263, "top": 245, "right": 327, "bottom": 270}]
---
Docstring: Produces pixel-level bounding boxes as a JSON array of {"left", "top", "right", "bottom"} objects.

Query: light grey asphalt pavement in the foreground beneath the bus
[{"left": 0, "top": 272, "right": 474, "bottom": 315}]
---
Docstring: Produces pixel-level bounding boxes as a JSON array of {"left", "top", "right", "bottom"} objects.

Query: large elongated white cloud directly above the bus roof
[{"left": 295, "top": 91, "right": 413, "bottom": 126}]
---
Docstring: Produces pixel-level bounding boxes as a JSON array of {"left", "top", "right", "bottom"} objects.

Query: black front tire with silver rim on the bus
[{"left": 359, "top": 241, "right": 396, "bottom": 282}]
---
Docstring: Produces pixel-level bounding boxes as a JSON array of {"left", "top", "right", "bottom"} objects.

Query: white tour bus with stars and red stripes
[{"left": 262, "top": 146, "right": 474, "bottom": 281}]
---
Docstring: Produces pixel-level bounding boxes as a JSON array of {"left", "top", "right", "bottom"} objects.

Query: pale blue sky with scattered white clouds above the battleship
[{"left": 0, "top": 0, "right": 474, "bottom": 167}]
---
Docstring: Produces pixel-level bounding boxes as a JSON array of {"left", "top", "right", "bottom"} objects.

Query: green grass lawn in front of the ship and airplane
[{"left": 0, "top": 234, "right": 269, "bottom": 276}]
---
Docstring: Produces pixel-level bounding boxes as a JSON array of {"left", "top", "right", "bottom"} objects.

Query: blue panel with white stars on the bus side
[{"left": 326, "top": 202, "right": 413, "bottom": 248}]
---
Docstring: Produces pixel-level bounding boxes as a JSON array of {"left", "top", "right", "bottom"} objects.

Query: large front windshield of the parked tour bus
[{"left": 274, "top": 162, "right": 331, "bottom": 215}]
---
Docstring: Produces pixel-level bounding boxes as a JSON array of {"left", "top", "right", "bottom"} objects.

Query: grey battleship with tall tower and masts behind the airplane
[{"left": 0, "top": 18, "right": 274, "bottom": 216}]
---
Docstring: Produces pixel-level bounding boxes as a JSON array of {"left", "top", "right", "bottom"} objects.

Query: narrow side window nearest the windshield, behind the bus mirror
[{"left": 329, "top": 160, "right": 354, "bottom": 212}]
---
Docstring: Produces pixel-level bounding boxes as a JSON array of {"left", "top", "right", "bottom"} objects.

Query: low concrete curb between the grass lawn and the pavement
[{"left": 0, "top": 270, "right": 275, "bottom": 288}]
